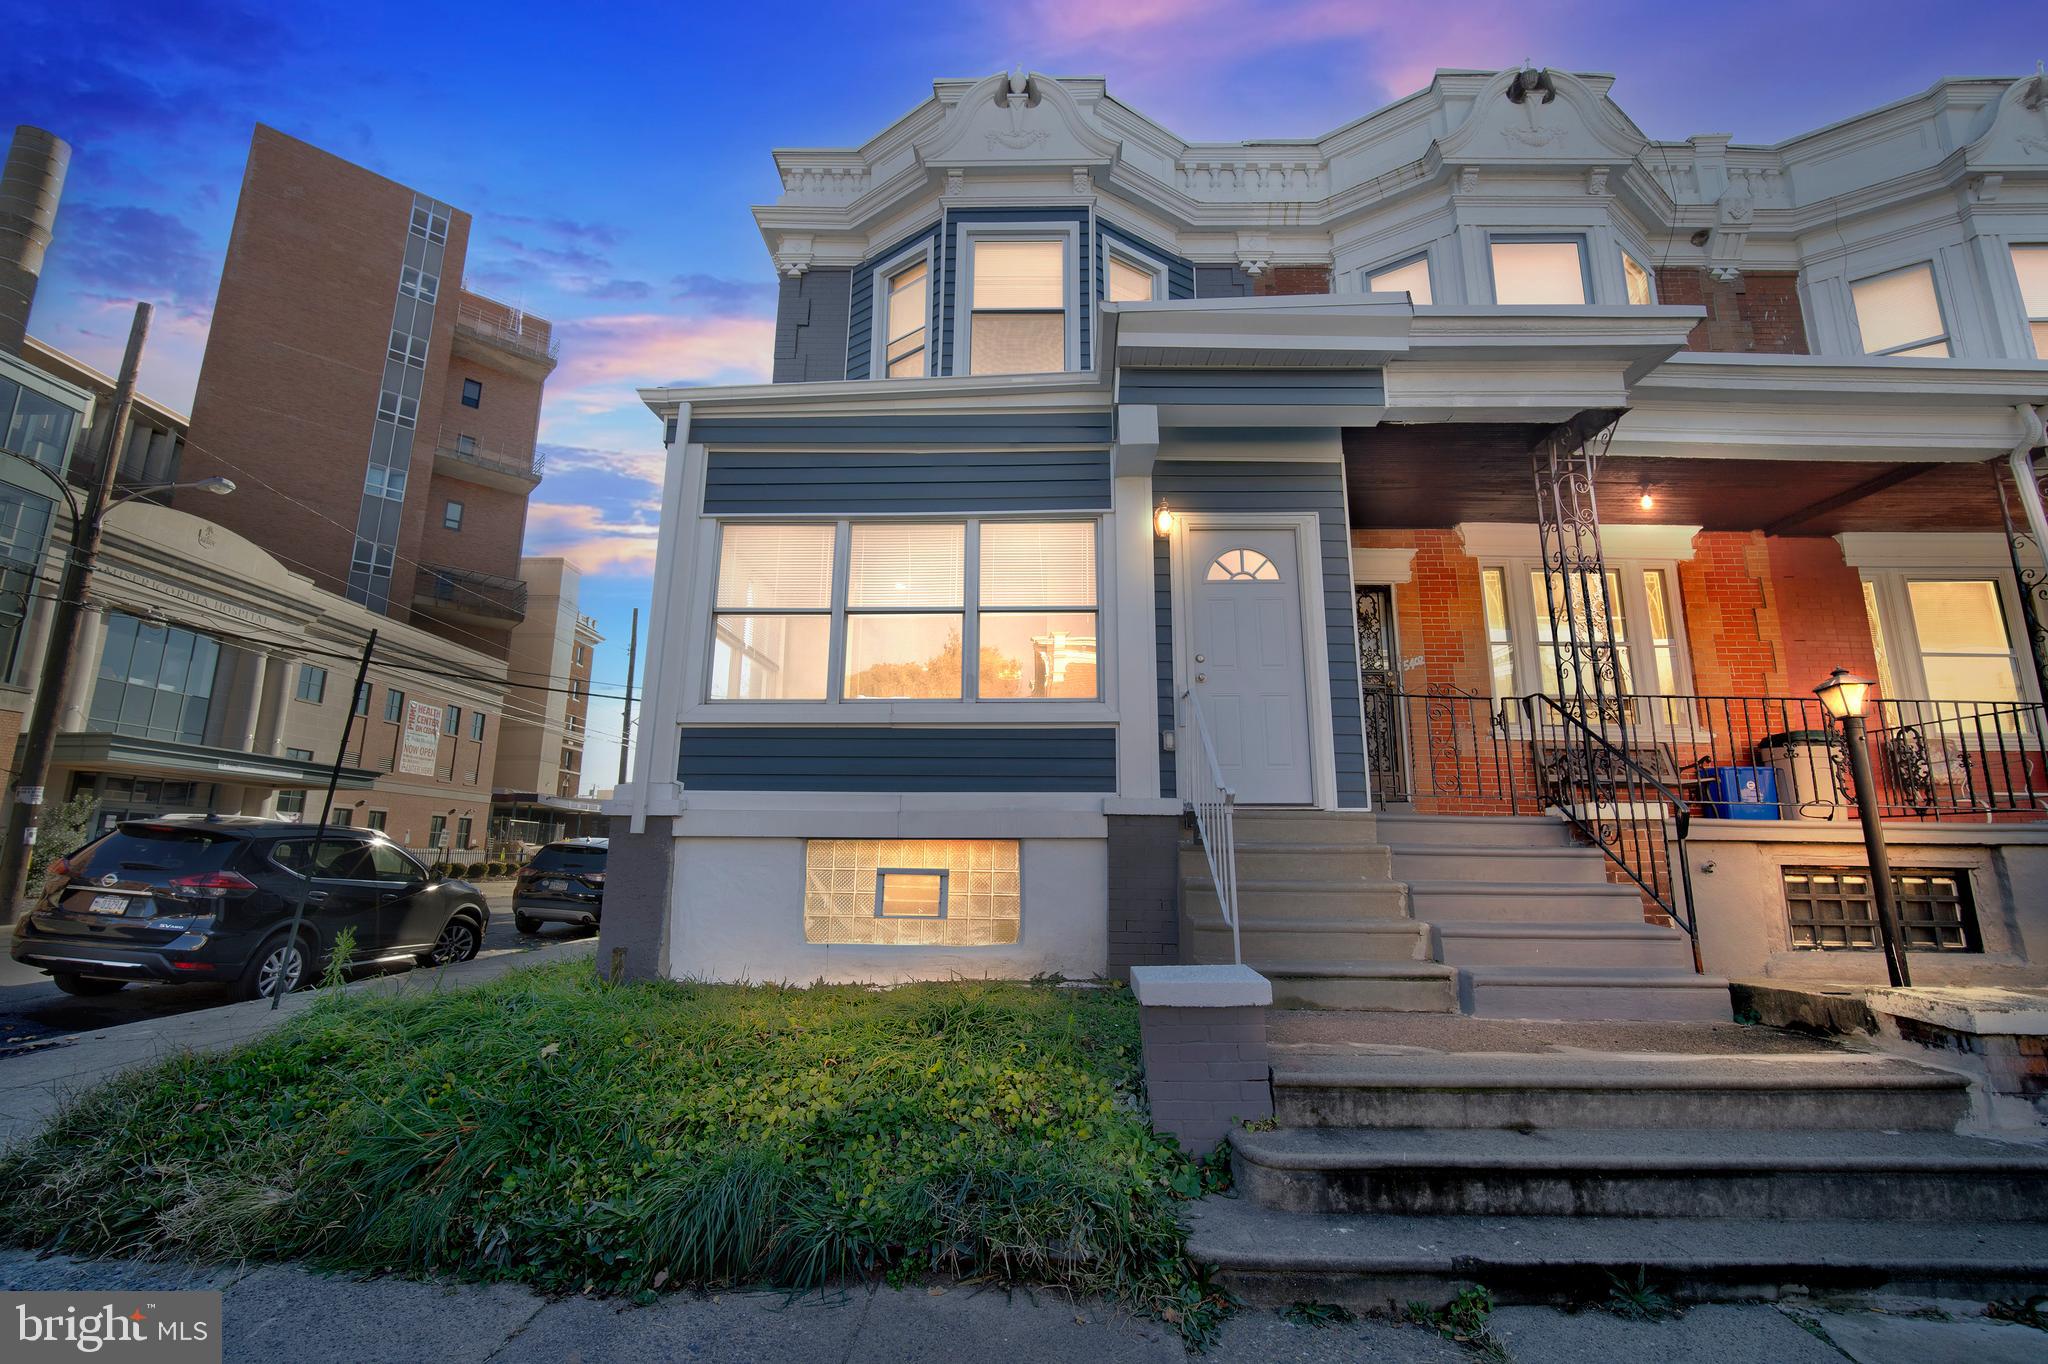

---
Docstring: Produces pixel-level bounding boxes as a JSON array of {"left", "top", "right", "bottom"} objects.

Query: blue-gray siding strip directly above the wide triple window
[{"left": 705, "top": 451, "right": 1110, "bottom": 516}]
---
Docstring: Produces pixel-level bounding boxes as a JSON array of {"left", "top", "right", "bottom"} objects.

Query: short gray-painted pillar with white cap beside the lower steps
[{"left": 1130, "top": 962, "right": 1274, "bottom": 1155}]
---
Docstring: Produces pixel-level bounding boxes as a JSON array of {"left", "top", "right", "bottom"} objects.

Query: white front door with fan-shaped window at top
[{"left": 1186, "top": 526, "right": 1315, "bottom": 805}]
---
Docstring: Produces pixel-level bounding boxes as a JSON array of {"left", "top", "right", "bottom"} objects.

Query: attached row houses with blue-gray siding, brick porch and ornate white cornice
[{"left": 604, "top": 70, "right": 2048, "bottom": 1018}]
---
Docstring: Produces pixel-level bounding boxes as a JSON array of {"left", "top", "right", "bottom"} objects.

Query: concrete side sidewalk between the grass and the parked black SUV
[{"left": 0, "top": 938, "right": 596, "bottom": 1149}]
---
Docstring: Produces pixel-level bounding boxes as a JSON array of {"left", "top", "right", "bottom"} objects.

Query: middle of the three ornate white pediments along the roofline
[{"left": 1436, "top": 70, "right": 1647, "bottom": 165}]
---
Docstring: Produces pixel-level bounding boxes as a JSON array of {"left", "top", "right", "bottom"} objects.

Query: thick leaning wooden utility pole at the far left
[{"left": 0, "top": 303, "right": 152, "bottom": 924}]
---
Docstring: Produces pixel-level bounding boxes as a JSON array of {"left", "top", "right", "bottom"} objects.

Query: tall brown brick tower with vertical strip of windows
[{"left": 178, "top": 125, "right": 557, "bottom": 657}]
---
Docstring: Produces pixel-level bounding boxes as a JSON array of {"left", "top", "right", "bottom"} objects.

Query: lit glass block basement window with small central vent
[{"left": 803, "top": 838, "right": 1024, "bottom": 946}]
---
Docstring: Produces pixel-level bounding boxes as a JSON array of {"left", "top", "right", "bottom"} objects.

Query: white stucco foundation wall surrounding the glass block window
[{"left": 668, "top": 821, "right": 1110, "bottom": 985}]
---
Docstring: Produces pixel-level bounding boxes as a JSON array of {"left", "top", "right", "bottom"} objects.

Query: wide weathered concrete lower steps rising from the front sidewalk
[{"left": 1188, "top": 1014, "right": 2048, "bottom": 1309}]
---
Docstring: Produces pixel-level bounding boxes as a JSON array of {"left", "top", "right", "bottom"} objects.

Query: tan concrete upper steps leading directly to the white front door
[{"left": 1180, "top": 811, "right": 1458, "bottom": 1014}]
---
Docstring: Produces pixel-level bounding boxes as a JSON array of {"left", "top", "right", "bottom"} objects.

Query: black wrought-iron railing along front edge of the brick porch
[{"left": 1366, "top": 688, "right": 2048, "bottom": 823}]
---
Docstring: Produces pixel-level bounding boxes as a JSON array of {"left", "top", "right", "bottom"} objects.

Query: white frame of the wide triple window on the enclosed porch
[{"left": 704, "top": 508, "right": 1116, "bottom": 725}]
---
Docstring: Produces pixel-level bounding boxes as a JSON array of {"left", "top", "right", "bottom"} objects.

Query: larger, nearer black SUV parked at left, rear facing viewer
[{"left": 14, "top": 815, "right": 492, "bottom": 999}]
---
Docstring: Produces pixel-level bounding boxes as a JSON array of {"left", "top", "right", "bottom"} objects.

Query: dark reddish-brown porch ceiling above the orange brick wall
[{"left": 1343, "top": 422, "right": 2003, "bottom": 535}]
